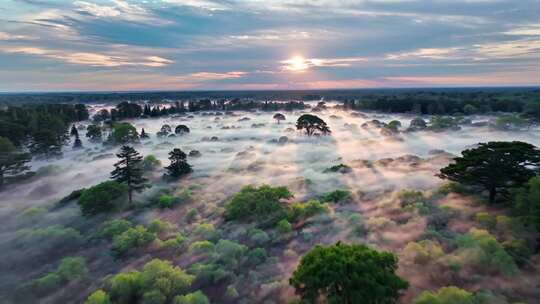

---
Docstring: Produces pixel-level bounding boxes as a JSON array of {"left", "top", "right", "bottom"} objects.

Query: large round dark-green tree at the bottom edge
[{"left": 289, "top": 242, "right": 408, "bottom": 304}]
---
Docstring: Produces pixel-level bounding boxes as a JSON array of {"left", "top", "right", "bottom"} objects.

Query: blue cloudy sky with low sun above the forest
[{"left": 0, "top": 0, "right": 540, "bottom": 92}]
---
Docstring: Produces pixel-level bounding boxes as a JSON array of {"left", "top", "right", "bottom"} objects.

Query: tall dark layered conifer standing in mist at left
[{"left": 111, "top": 146, "right": 146, "bottom": 204}]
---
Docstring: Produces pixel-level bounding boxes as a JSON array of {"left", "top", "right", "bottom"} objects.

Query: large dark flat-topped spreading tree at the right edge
[{"left": 438, "top": 141, "right": 540, "bottom": 204}]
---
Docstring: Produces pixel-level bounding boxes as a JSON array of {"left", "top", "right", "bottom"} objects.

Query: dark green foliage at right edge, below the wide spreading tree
[{"left": 513, "top": 176, "right": 540, "bottom": 231}]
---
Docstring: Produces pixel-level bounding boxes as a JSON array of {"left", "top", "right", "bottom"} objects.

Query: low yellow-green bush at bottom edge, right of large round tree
[{"left": 413, "top": 286, "right": 476, "bottom": 304}]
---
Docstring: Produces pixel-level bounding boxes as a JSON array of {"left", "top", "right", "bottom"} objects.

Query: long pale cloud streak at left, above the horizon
[{"left": 0, "top": 47, "right": 173, "bottom": 68}]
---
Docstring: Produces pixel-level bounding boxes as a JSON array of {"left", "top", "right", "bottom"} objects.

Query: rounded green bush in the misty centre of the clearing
[{"left": 225, "top": 185, "right": 292, "bottom": 223}]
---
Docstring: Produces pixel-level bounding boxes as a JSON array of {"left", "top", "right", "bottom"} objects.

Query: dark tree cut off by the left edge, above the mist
[{"left": 0, "top": 137, "right": 30, "bottom": 189}]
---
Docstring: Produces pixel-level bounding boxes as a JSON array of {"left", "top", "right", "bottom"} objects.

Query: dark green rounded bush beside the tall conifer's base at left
[{"left": 78, "top": 181, "right": 128, "bottom": 215}]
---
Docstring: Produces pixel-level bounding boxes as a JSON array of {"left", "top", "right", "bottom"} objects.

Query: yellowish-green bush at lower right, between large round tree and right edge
[{"left": 455, "top": 228, "right": 518, "bottom": 276}]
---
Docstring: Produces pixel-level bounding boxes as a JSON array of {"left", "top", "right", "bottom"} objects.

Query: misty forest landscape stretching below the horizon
[{"left": 0, "top": 93, "right": 540, "bottom": 304}]
